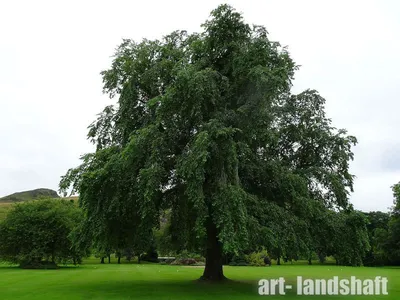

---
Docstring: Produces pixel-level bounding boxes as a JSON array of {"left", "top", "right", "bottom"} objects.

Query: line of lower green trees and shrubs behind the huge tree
[{"left": 0, "top": 193, "right": 400, "bottom": 268}]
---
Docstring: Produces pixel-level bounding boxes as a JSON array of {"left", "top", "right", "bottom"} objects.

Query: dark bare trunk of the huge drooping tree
[{"left": 200, "top": 222, "right": 226, "bottom": 281}]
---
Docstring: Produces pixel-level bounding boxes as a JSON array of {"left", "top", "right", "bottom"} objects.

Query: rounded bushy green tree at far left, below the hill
[{"left": 0, "top": 199, "right": 83, "bottom": 268}]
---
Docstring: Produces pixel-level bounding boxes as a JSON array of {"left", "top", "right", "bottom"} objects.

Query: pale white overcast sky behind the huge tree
[{"left": 0, "top": 0, "right": 400, "bottom": 211}]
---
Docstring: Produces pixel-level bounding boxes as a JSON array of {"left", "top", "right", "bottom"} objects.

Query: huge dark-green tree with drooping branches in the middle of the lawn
[{"left": 60, "top": 5, "right": 356, "bottom": 280}]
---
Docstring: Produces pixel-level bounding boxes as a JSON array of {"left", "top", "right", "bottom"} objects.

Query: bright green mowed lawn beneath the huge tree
[{"left": 0, "top": 260, "right": 400, "bottom": 300}]
